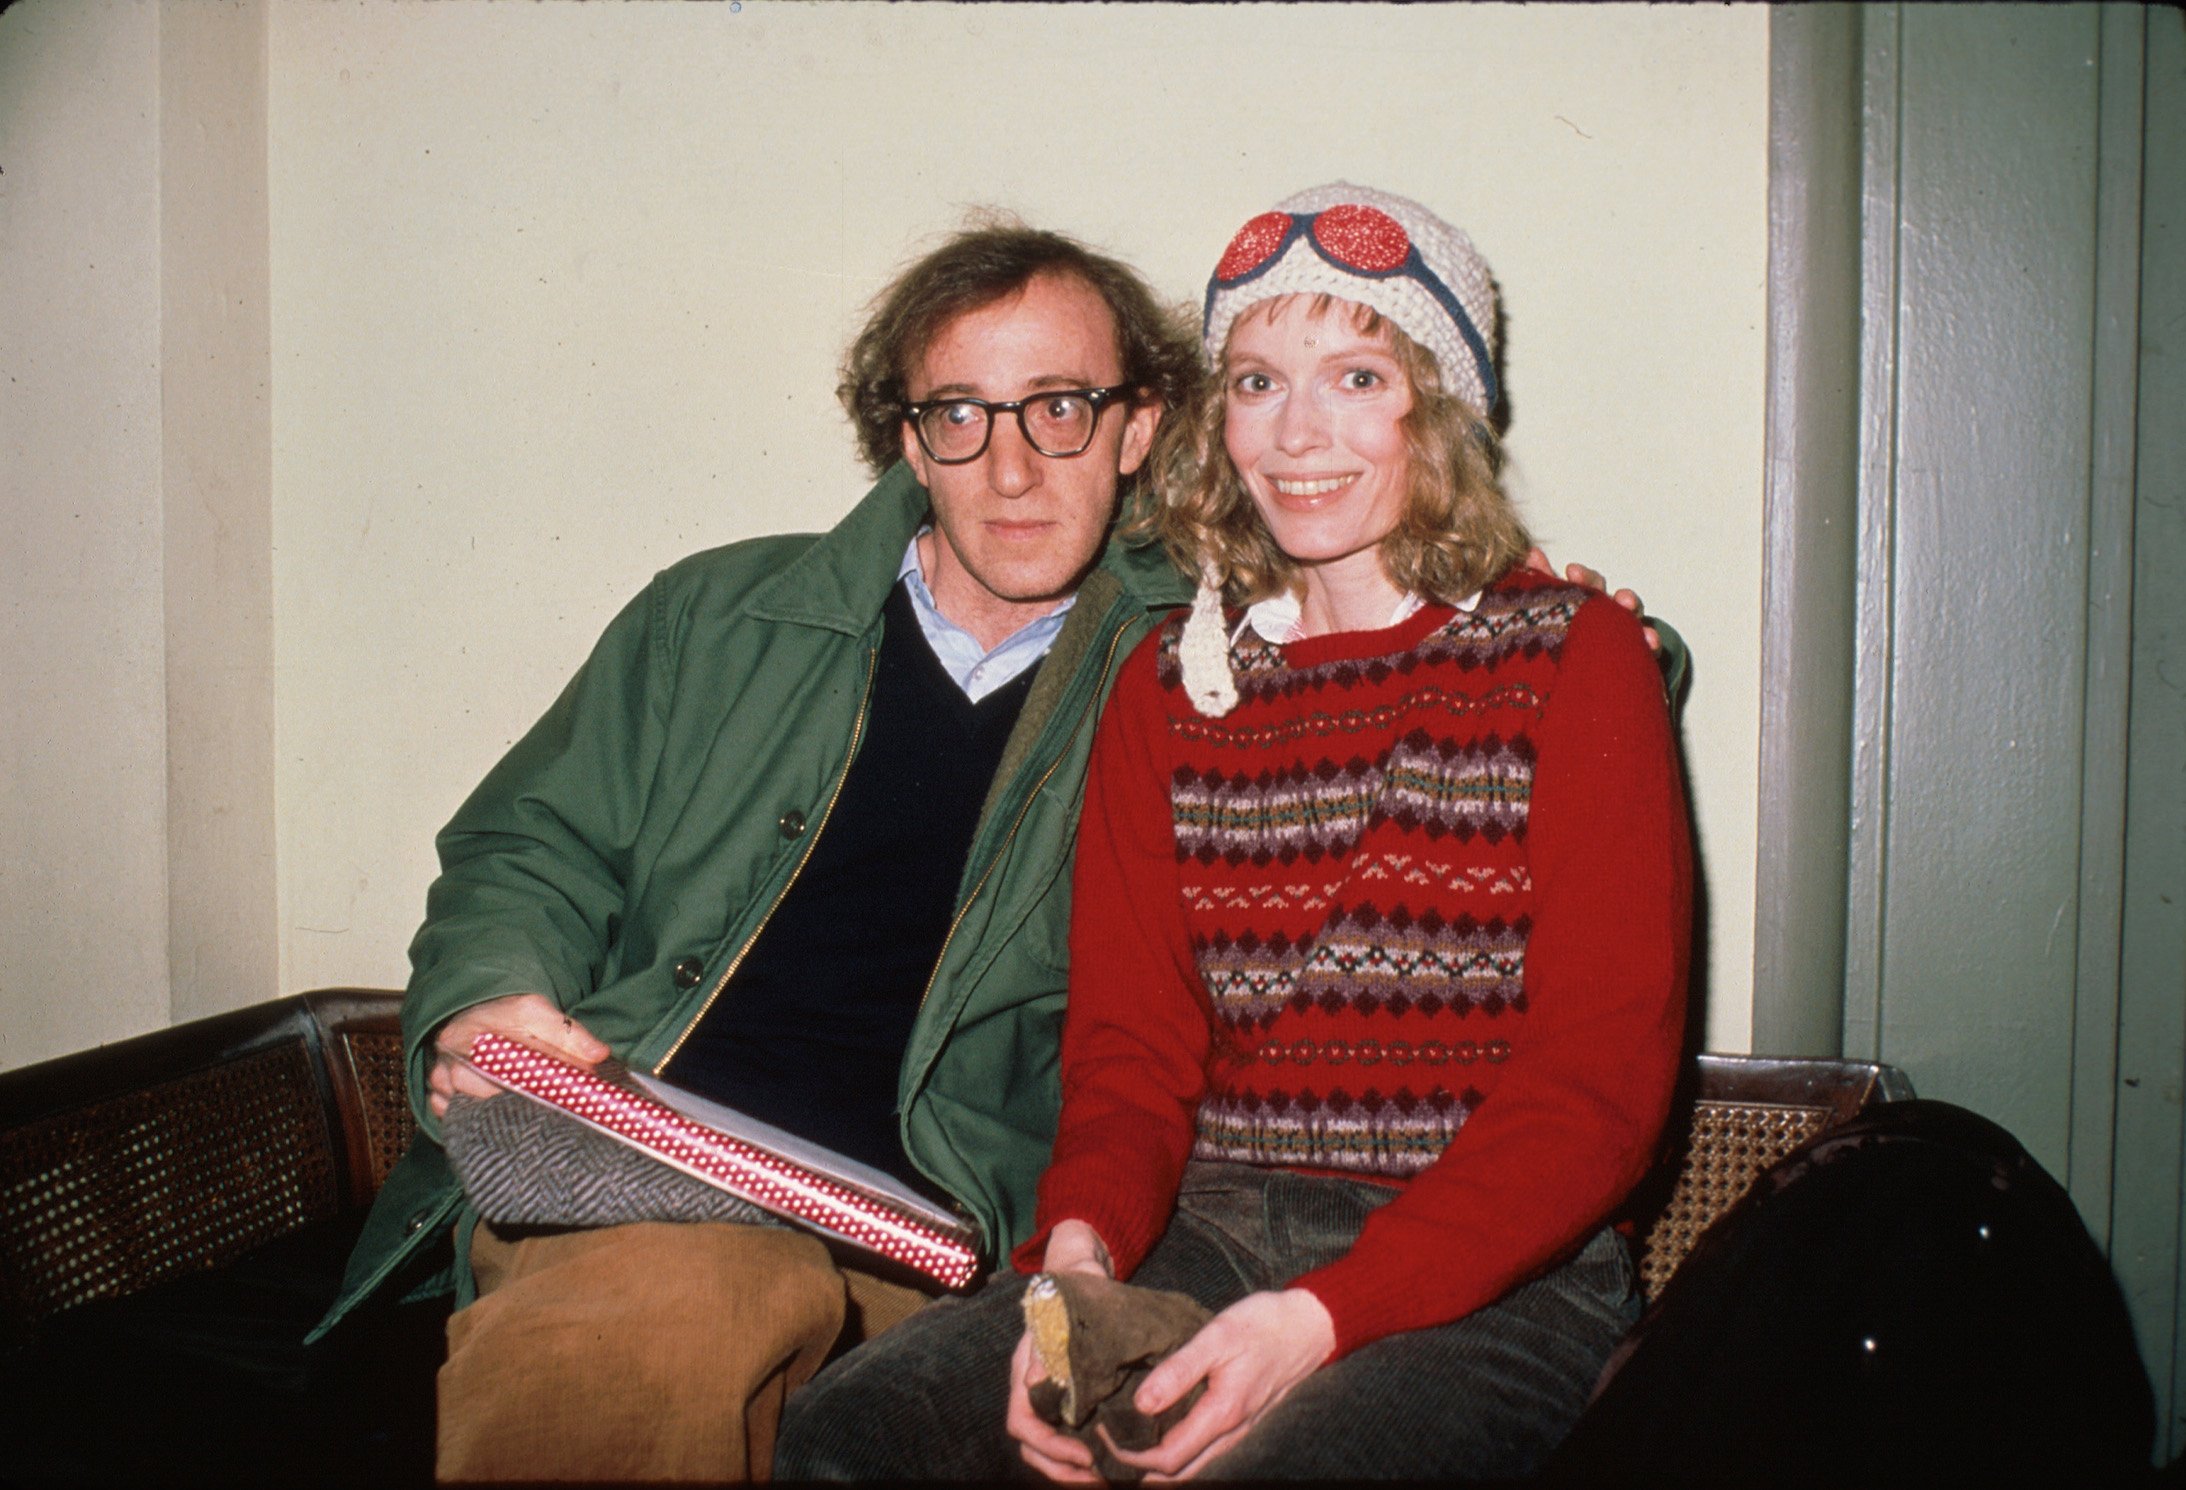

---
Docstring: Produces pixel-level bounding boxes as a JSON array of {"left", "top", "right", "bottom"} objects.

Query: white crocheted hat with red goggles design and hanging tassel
[{"left": 1178, "top": 181, "right": 1497, "bottom": 717}]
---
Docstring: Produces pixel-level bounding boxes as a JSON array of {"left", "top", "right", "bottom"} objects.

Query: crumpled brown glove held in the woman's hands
[{"left": 1025, "top": 1274, "right": 1213, "bottom": 1481}]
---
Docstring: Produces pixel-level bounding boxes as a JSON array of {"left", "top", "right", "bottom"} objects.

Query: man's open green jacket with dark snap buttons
[{"left": 313, "top": 463, "right": 1191, "bottom": 1337}]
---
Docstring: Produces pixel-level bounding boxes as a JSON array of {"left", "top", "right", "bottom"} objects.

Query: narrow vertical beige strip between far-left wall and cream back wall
[{"left": 160, "top": 0, "right": 280, "bottom": 1022}]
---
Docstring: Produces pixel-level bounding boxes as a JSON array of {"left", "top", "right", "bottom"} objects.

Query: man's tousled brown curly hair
[{"left": 835, "top": 214, "right": 1200, "bottom": 476}]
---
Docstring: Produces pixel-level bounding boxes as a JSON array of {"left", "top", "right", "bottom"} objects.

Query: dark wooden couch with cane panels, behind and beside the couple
[{"left": 0, "top": 990, "right": 1911, "bottom": 1486}]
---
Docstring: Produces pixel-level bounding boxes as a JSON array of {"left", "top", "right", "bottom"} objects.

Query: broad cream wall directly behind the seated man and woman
[{"left": 0, "top": 0, "right": 1766, "bottom": 1066}]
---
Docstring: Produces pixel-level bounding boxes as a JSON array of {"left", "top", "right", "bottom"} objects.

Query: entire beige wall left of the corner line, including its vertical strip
[{"left": 0, "top": 0, "right": 278, "bottom": 1066}]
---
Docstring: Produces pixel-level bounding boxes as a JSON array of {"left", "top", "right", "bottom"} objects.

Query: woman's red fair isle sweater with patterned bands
[{"left": 1014, "top": 570, "right": 1692, "bottom": 1355}]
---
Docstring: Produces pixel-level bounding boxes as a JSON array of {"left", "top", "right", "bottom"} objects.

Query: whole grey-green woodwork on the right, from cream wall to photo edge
[{"left": 1753, "top": 4, "right": 2186, "bottom": 1459}]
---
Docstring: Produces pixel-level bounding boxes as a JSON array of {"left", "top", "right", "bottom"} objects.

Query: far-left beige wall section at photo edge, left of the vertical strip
[{"left": 0, "top": 4, "right": 168, "bottom": 1064}]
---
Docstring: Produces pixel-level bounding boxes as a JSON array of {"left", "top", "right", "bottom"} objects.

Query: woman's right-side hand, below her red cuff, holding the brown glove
[{"left": 1110, "top": 1289, "right": 1336, "bottom": 1481}]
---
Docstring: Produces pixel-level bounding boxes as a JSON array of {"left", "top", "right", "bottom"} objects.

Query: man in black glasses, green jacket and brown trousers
[{"left": 321, "top": 227, "right": 1198, "bottom": 1479}]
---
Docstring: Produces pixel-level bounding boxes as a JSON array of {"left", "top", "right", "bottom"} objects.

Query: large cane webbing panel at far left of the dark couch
[{"left": 0, "top": 1040, "right": 339, "bottom": 1320}]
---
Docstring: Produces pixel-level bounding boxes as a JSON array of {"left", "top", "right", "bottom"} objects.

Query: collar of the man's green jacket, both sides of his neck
[{"left": 750, "top": 461, "right": 1191, "bottom": 636}]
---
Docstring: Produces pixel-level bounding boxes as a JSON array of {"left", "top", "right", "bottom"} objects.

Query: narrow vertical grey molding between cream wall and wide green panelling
[{"left": 1753, "top": 4, "right": 1860, "bottom": 1055}]
